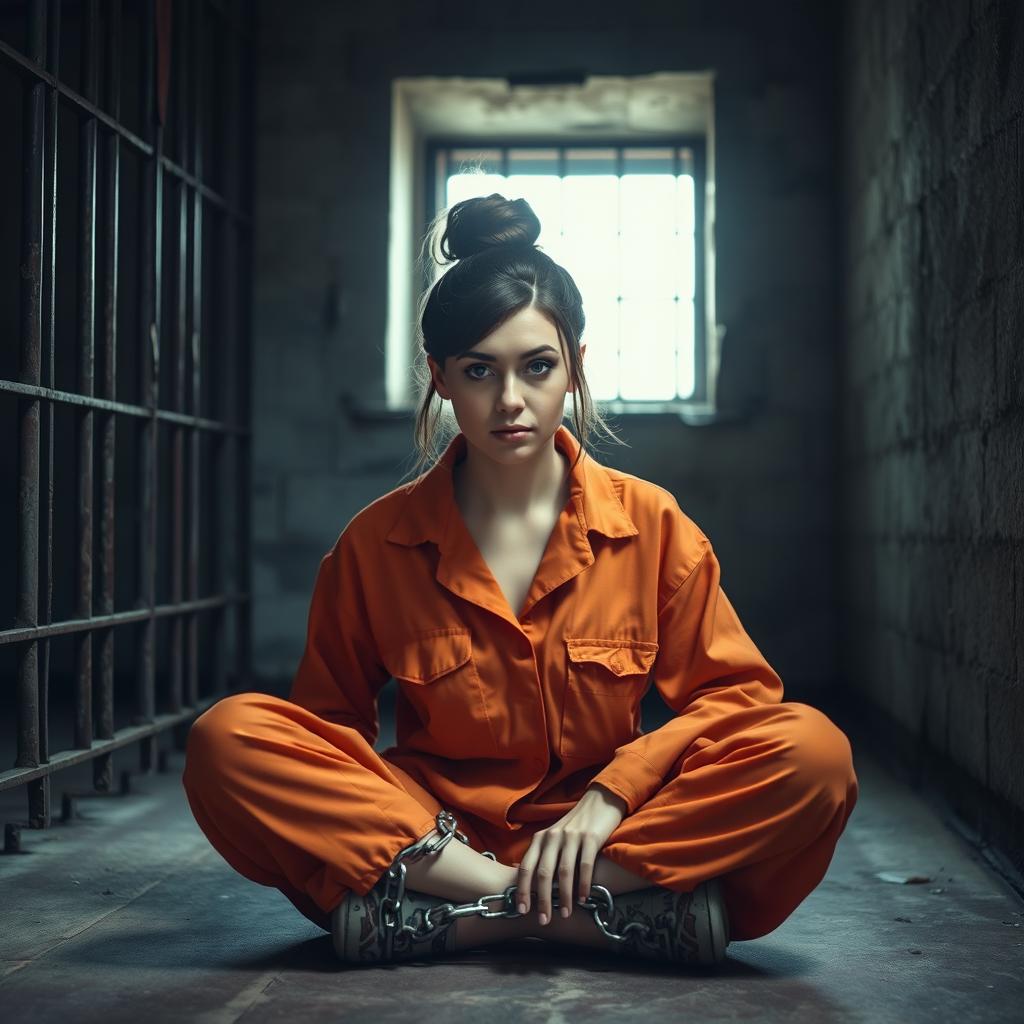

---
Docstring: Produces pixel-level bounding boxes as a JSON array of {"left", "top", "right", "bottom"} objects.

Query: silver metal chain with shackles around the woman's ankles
[{"left": 381, "top": 810, "right": 652, "bottom": 961}]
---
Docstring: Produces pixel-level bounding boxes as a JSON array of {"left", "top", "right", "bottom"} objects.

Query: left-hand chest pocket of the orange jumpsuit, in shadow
[{"left": 381, "top": 627, "right": 498, "bottom": 759}]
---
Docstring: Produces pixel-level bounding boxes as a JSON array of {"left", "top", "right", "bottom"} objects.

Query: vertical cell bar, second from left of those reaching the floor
[{"left": 92, "top": 0, "right": 121, "bottom": 793}]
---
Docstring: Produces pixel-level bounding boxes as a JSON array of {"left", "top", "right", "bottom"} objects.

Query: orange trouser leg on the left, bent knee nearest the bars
[{"left": 181, "top": 692, "right": 471, "bottom": 929}]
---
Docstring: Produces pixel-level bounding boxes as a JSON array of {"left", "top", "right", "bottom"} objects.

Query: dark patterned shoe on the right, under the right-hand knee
[{"left": 595, "top": 879, "right": 729, "bottom": 965}]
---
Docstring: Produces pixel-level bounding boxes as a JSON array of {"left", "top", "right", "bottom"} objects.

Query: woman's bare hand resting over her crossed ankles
[{"left": 516, "top": 783, "right": 626, "bottom": 925}]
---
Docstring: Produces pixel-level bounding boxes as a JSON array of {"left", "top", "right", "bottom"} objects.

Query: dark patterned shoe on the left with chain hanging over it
[{"left": 331, "top": 873, "right": 455, "bottom": 964}]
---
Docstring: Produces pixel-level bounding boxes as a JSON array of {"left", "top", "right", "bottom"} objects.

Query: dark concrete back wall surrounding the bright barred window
[{"left": 247, "top": 0, "right": 839, "bottom": 696}]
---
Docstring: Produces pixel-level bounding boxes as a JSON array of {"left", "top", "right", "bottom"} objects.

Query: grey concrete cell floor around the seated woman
[{"left": 0, "top": 701, "right": 1024, "bottom": 1024}]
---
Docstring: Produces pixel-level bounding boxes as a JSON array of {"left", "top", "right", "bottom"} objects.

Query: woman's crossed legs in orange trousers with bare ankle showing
[{"left": 182, "top": 692, "right": 857, "bottom": 944}]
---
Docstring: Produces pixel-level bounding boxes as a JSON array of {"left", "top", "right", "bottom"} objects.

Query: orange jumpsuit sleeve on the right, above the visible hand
[{"left": 591, "top": 535, "right": 782, "bottom": 814}]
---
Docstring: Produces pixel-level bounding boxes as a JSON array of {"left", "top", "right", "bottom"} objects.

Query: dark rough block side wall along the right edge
[{"left": 839, "top": 0, "right": 1024, "bottom": 853}]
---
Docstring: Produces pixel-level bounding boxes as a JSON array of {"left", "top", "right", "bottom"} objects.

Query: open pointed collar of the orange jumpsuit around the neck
[{"left": 387, "top": 424, "right": 639, "bottom": 627}]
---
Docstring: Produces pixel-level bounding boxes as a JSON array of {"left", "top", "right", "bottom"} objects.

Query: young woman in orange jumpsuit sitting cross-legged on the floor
[{"left": 183, "top": 195, "right": 857, "bottom": 964}]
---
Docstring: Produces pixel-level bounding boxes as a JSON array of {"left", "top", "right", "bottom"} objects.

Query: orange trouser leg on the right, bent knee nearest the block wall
[{"left": 601, "top": 701, "right": 858, "bottom": 939}]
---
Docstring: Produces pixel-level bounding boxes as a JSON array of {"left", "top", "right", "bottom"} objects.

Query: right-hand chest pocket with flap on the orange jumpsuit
[{"left": 559, "top": 637, "right": 658, "bottom": 763}]
